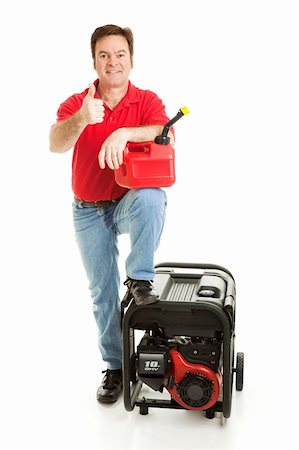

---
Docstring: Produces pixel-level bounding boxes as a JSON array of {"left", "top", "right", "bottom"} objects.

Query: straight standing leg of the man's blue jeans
[{"left": 73, "top": 203, "right": 122, "bottom": 370}]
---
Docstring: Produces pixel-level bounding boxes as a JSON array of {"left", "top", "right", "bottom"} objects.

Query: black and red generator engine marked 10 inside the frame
[{"left": 136, "top": 332, "right": 222, "bottom": 411}]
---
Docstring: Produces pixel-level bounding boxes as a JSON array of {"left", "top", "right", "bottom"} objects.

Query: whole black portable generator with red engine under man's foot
[{"left": 122, "top": 263, "right": 244, "bottom": 420}]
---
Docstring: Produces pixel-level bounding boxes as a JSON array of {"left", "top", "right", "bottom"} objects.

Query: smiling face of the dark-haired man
[{"left": 94, "top": 35, "right": 132, "bottom": 88}]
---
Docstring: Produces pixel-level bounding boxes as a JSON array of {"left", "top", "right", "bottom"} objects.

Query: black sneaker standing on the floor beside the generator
[{"left": 97, "top": 369, "right": 123, "bottom": 403}]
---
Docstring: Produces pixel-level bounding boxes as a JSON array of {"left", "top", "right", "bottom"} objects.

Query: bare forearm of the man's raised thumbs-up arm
[{"left": 50, "top": 110, "right": 87, "bottom": 153}]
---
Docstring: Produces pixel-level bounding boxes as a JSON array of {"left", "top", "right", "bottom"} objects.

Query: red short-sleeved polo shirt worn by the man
[{"left": 57, "top": 80, "right": 169, "bottom": 201}]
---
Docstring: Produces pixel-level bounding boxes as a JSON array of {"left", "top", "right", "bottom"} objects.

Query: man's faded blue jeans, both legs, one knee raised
[{"left": 73, "top": 189, "right": 167, "bottom": 370}]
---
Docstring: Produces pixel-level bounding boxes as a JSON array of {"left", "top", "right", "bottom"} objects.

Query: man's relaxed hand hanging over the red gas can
[{"left": 98, "top": 128, "right": 128, "bottom": 170}]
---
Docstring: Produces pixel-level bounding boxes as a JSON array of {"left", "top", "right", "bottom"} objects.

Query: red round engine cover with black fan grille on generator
[{"left": 166, "top": 349, "right": 222, "bottom": 411}]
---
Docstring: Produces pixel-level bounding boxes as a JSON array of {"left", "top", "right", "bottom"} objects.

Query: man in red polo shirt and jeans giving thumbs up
[{"left": 50, "top": 25, "right": 173, "bottom": 403}]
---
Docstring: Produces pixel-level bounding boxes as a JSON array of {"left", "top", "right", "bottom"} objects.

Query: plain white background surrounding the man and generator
[{"left": 1, "top": 0, "right": 299, "bottom": 450}]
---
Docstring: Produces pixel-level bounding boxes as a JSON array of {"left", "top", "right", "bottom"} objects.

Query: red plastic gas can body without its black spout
[{"left": 114, "top": 142, "right": 175, "bottom": 189}]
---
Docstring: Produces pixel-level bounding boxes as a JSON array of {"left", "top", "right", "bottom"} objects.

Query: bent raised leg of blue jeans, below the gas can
[{"left": 114, "top": 189, "right": 167, "bottom": 280}]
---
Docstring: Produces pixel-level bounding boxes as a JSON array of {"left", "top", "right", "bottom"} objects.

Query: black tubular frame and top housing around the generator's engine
[{"left": 122, "top": 262, "right": 244, "bottom": 419}]
